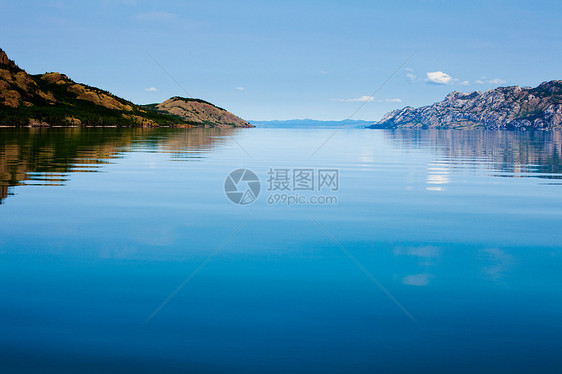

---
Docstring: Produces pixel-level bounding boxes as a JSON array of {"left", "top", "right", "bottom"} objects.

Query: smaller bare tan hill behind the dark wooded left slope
[{"left": 152, "top": 96, "right": 254, "bottom": 127}]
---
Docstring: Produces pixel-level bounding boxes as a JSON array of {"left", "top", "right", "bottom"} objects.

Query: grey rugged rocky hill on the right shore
[{"left": 369, "top": 81, "right": 562, "bottom": 130}]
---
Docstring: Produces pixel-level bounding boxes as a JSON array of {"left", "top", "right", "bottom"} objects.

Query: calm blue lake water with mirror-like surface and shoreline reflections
[{"left": 0, "top": 129, "right": 562, "bottom": 373}]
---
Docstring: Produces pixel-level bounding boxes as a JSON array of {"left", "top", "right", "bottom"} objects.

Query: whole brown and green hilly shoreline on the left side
[{"left": 0, "top": 49, "right": 249, "bottom": 127}]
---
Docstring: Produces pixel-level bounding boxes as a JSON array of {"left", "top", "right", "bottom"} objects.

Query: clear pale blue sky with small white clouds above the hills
[{"left": 0, "top": 0, "right": 562, "bottom": 120}]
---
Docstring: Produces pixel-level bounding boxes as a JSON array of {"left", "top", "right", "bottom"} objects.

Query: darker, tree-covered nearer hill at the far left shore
[{"left": 0, "top": 49, "right": 196, "bottom": 127}]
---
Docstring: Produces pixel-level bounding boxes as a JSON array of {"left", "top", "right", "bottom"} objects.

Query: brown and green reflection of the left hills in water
[{"left": 0, "top": 128, "right": 237, "bottom": 204}]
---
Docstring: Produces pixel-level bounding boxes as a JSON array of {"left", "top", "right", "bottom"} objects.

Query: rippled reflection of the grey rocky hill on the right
[{"left": 385, "top": 130, "right": 562, "bottom": 179}]
